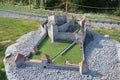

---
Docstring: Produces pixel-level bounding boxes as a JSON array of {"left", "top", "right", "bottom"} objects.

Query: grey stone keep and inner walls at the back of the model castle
[{"left": 48, "top": 15, "right": 86, "bottom": 43}]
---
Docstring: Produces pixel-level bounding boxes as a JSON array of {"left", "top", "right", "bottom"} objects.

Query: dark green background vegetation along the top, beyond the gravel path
[{"left": 0, "top": 0, "right": 120, "bottom": 16}]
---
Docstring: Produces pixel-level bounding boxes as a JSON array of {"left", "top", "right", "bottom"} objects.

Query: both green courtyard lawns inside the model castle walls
[{"left": 31, "top": 37, "right": 83, "bottom": 64}]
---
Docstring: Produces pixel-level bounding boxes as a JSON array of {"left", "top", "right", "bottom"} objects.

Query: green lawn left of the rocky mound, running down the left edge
[{"left": 0, "top": 17, "right": 41, "bottom": 80}]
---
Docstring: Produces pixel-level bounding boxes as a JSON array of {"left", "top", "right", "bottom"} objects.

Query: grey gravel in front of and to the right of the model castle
[{"left": 4, "top": 33, "right": 120, "bottom": 80}]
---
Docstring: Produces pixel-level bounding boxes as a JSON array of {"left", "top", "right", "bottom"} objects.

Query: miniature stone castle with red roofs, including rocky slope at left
[{"left": 4, "top": 15, "right": 93, "bottom": 79}]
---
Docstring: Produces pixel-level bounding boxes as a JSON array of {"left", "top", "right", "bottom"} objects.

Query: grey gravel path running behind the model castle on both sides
[{"left": 0, "top": 9, "right": 120, "bottom": 28}]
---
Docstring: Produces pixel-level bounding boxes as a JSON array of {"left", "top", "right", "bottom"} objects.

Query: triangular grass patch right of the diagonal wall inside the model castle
[{"left": 55, "top": 44, "right": 83, "bottom": 64}]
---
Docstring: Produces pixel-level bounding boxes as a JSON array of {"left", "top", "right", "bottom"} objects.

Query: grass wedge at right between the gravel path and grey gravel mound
[{"left": 92, "top": 27, "right": 120, "bottom": 42}]
